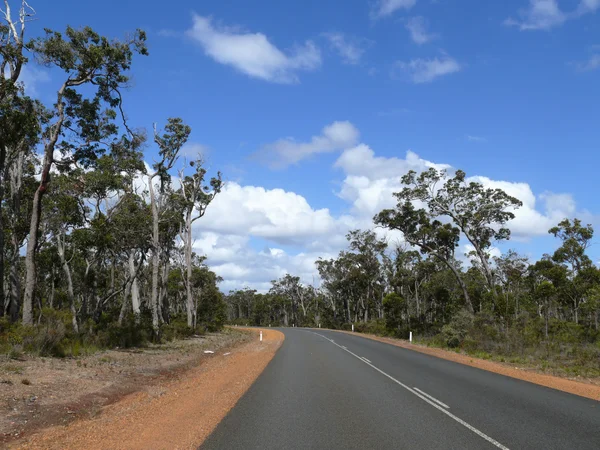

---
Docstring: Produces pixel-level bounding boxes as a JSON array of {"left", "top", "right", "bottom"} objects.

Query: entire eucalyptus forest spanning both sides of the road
[{"left": 0, "top": 1, "right": 600, "bottom": 375}]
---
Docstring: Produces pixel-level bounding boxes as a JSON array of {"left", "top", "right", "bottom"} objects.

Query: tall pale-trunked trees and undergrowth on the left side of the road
[{"left": 0, "top": 0, "right": 226, "bottom": 358}]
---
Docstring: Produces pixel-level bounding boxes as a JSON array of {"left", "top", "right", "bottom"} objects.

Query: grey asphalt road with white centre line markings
[{"left": 201, "top": 328, "right": 600, "bottom": 450}]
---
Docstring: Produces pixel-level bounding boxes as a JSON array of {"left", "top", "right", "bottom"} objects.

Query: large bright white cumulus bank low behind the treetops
[{"left": 180, "top": 122, "right": 589, "bottom": 291}]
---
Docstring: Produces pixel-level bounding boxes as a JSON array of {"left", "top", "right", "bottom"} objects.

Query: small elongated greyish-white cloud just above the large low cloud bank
[{"left": 255, "top": 121, "right": 360, "bottom": 168}]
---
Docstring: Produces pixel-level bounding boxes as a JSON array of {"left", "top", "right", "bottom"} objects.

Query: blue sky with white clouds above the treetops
[{"left": 26, "top": 0, "right": 600, "bottom": 290}]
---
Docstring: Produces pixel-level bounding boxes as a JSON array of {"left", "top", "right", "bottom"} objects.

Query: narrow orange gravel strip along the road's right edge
[{"left": 332, "top": 330, "right": 600, "bottom": 401}]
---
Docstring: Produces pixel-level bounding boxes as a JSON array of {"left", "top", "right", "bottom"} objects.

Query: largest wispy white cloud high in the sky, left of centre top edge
[{"left": 186, "top": 14, "right": 321, "bottom": 83}]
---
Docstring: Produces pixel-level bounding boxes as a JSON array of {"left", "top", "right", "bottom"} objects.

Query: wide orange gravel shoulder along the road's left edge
[{"left": 12, "top": 329, "right": 284, "bottom": 449}]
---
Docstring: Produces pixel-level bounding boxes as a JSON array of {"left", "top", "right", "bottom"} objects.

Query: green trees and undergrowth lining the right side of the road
[{"left": 226, "top": 168, "right": 600, "bottom": 377}]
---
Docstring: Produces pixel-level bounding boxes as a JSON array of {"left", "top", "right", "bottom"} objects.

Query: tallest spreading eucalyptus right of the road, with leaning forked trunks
[{"left": 375, "top": 167, "right": 522, "bottom": 312}]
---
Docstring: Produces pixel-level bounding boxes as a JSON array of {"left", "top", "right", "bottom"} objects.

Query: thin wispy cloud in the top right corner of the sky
[{"left": 504, "top": 0, "right": 600, "bottom": 31}]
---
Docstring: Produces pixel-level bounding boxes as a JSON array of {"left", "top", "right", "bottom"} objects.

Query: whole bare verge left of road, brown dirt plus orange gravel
[{"left": 0, "top": 329, "right": 283, "bottom": 448}]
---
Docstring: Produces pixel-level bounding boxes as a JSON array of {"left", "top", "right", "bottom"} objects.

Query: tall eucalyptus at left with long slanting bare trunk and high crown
[{"left": 23, "top": 27, "right": 147, "bottom": 325}]
